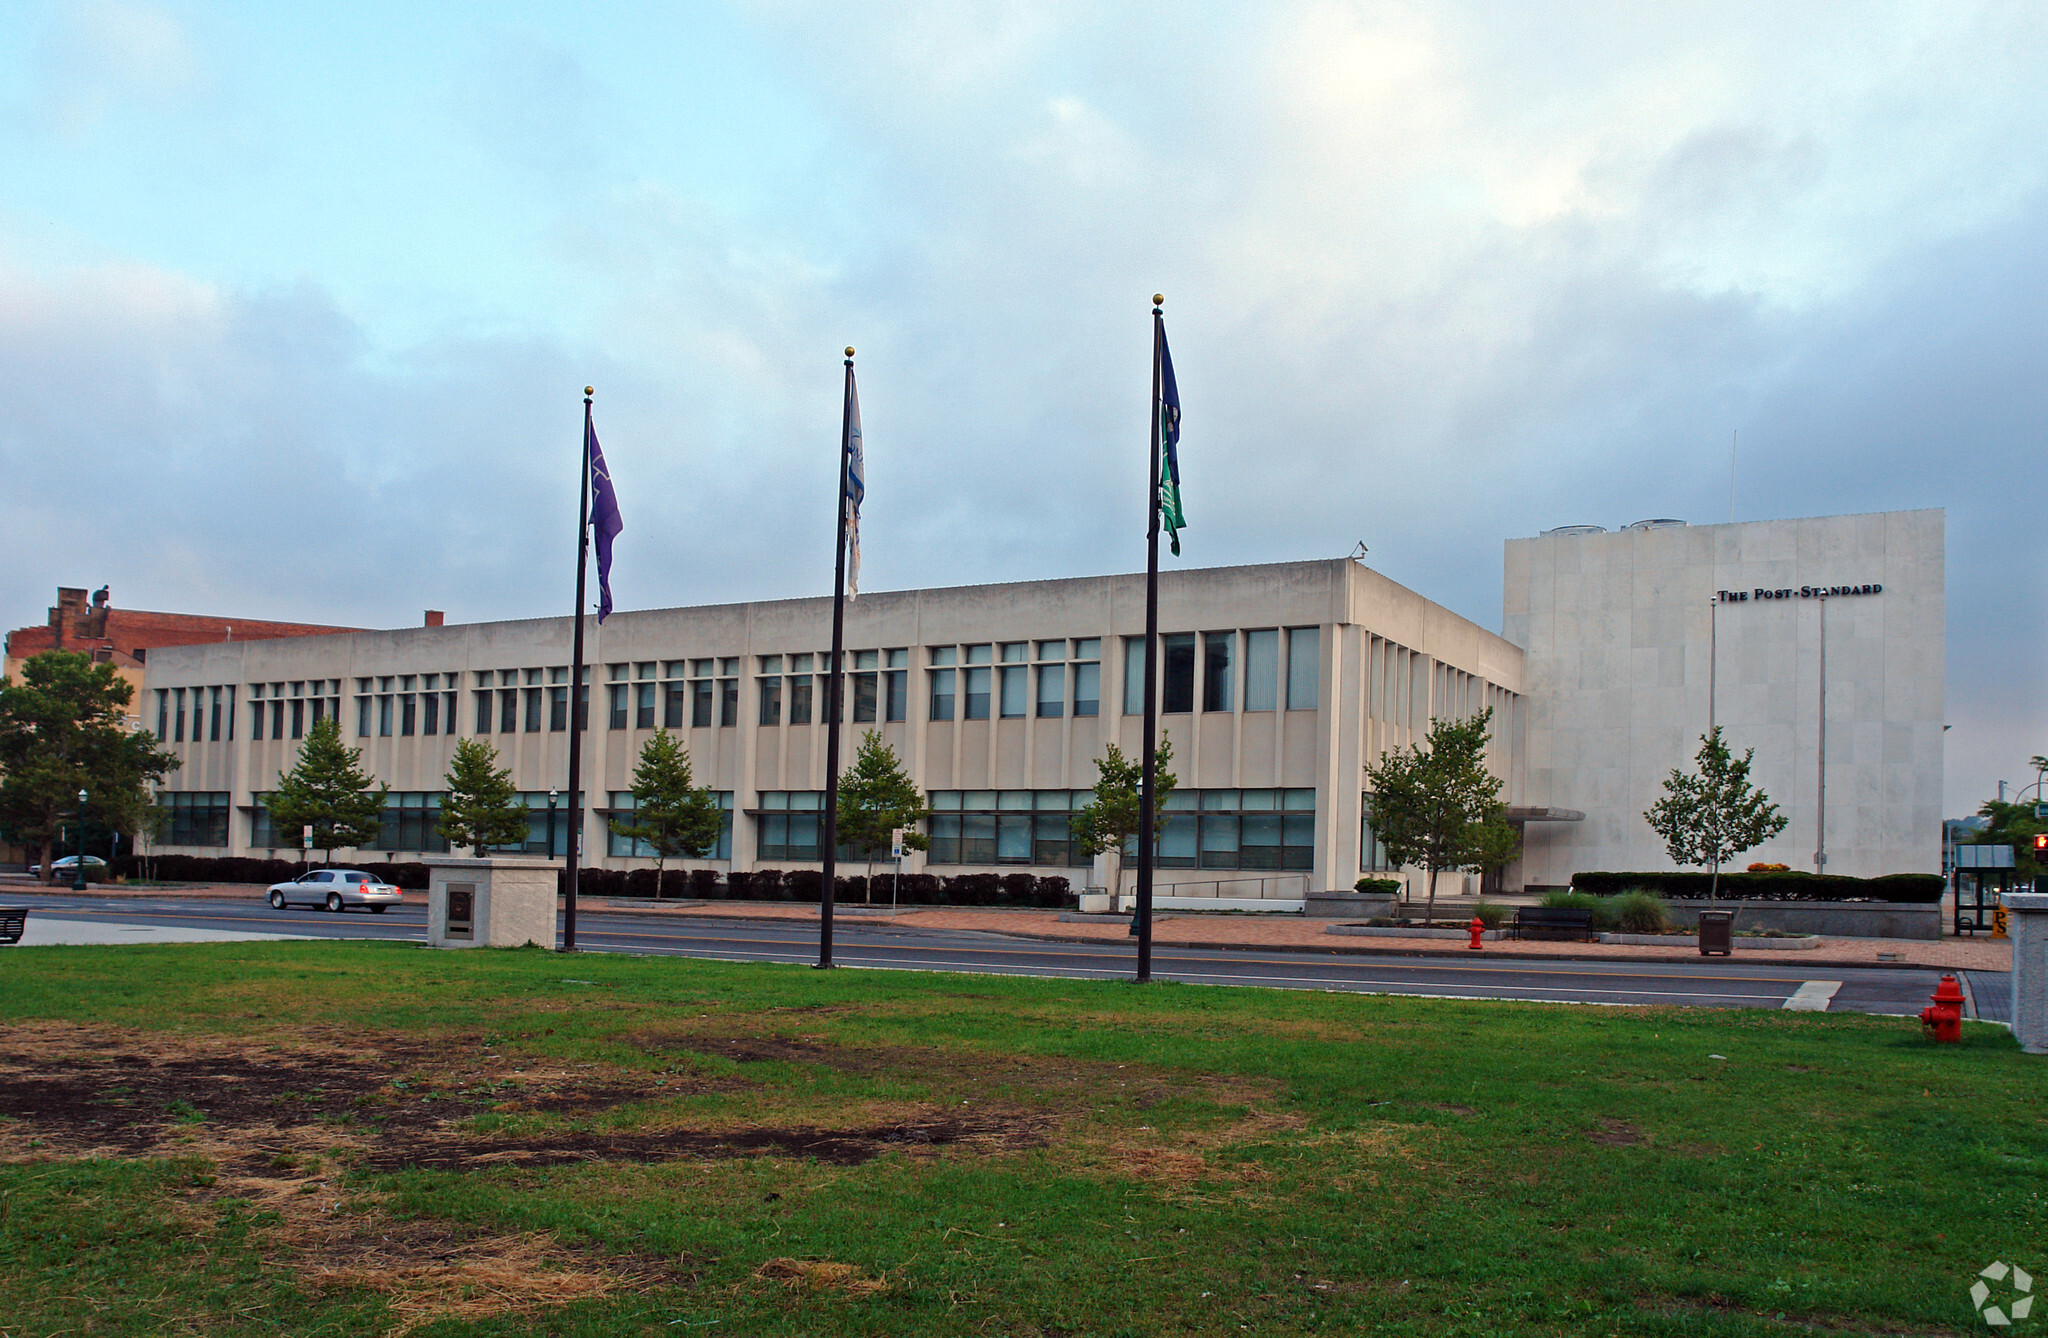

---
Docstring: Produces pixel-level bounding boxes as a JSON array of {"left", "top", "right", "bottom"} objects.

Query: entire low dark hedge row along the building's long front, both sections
[{"left": 109, "top": 854, "right": 1073, "bottom": 908}]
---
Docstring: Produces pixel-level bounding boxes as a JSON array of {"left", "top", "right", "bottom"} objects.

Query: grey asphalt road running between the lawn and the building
[{"left": 6, "top": 895, "right": 2005, "bottom": 1016}]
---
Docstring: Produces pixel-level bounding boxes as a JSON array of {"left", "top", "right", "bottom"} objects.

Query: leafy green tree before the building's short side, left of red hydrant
[{"left": 1366, "top": 707, "right": 1522, "bottom": 918}]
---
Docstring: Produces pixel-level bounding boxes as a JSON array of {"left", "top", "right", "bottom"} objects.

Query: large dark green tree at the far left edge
[{"left": 0, "top": 650, "right": 178, "bottom": 883}]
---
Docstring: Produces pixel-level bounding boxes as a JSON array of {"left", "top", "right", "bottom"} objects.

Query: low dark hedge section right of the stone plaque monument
[{"left": 575, "top": 869, "right": 1073, "bottom": 908}]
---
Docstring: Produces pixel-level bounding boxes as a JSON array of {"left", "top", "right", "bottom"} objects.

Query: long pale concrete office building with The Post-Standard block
[{"left": 143, "top": 512, "right": 1942, "bottom": 900}]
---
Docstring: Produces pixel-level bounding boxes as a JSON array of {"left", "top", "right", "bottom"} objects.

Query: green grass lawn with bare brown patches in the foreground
[{"left": 0, "top": 943, "right": 2048, "bottom": 1338}]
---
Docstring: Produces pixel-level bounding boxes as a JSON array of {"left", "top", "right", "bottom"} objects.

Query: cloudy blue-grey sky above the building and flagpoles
[{"left": 0, "top": 0, "right": 2048, "bottom": 813}]
